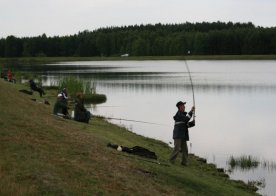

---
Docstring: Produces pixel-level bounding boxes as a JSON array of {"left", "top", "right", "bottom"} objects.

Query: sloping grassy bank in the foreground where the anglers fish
[{"left": 0, "top": 80, "right": 255, "bottom": 195}]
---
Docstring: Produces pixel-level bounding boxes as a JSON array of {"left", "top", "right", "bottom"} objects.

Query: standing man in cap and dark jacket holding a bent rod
[{"left": 170, "top": 101, "right": 195, "bottom": 166}]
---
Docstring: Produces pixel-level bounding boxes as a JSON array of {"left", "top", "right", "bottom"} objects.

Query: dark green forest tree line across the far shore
[{"left": 0, "top": 22, "right": 276, "bottom": 57}]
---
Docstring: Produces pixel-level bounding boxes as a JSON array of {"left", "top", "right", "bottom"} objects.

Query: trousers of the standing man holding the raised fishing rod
[{"left": 170, "top": 139, "right": 188, "bottom": 165}]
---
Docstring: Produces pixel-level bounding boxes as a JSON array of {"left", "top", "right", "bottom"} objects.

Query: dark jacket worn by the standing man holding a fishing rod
[{"left": 173, "top": 111, "right": 194, "bottom": 141}]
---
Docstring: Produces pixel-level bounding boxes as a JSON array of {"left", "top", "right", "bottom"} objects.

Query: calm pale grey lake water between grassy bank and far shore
[{"left": 18, "top": 60, "right": 276, "bottom": 195}]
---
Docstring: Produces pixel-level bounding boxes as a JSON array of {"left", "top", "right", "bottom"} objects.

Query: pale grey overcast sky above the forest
[{"left": 0, "top": 0, "right": 276, "bottom": 38}]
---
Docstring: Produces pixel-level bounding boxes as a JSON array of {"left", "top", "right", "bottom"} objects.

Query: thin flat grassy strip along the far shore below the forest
[{"left": 0, "top": 55, "right": 276, "bottom": 64}]
